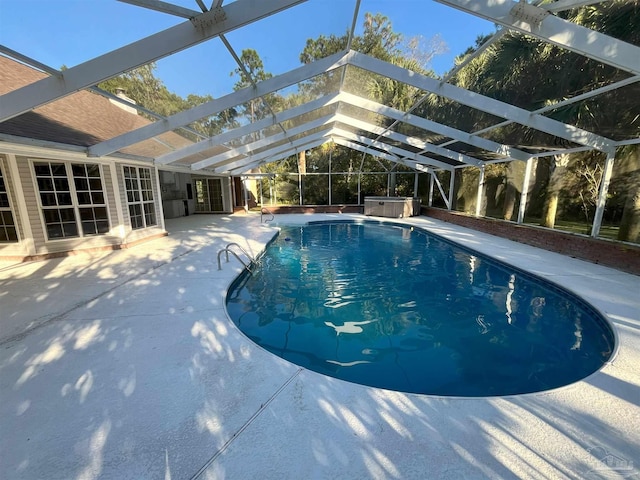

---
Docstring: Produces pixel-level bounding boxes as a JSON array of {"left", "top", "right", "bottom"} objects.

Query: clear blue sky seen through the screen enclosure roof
[{"left": 0, "top": 0, "right": 494, "bottom": 97}]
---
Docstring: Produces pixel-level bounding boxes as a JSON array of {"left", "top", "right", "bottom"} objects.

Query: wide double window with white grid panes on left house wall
[{"left": 34, "top": 162, "right": 109, "bottom": 240}]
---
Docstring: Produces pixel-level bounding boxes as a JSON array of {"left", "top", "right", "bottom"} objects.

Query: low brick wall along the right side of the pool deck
[{"left": 421, "top": 207, "right": 640, "bottom": 275}]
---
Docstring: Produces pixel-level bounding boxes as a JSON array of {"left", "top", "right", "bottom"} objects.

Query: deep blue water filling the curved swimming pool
[{"left": 227, "top": 222, "right": 614, "bottom": 396}]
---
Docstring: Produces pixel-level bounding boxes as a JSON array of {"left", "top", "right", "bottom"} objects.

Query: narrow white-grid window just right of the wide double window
[{"left": 124, "top": 166, "right": 157, "bottom": 230}]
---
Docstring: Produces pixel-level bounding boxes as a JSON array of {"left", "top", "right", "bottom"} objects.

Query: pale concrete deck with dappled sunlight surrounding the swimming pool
[{"left": 0, "top": 214, "right": 640, "bottom": 480}]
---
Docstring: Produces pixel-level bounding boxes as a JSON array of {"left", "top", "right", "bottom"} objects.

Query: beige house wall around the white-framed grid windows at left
[{"left": 0, "top": 145, "right": 166, "bottom": 260}]
